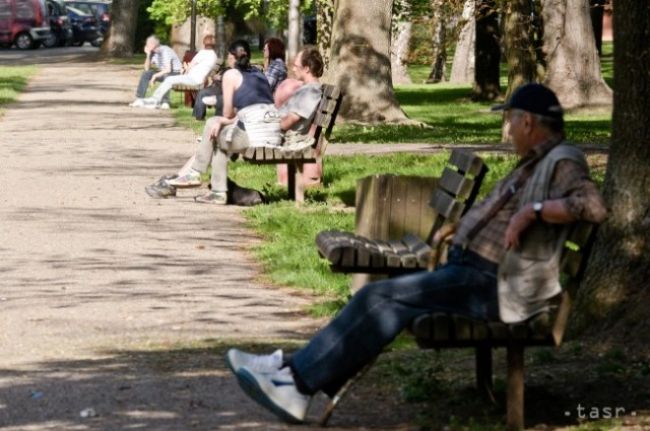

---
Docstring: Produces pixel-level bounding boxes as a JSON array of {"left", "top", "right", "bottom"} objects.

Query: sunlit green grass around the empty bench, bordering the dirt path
[{"left": 223, "top": 152, "right": 515, "bottom": 315}]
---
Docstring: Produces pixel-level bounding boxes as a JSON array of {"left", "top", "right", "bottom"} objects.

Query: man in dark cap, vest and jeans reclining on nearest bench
[{"left": 226, "top": 84, "right": 606, "bottom": 423}]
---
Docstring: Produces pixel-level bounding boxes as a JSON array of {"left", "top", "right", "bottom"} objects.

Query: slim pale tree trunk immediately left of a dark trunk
[{"left": 449, "top": 0, "right": 476, "bottom": 84}]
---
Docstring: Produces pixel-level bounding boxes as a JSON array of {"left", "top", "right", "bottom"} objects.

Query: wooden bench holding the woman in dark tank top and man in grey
[{"left": 242, "top": 84, "right": 343, "bottom": 202}]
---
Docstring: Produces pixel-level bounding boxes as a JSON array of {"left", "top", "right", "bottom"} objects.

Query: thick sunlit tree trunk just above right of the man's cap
[{"left": 542, "top": 0, "right": 620, "bottom": 108}]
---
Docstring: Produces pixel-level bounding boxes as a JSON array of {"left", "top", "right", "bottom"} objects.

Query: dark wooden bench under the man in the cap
[{"left": 411, "top": 223, "right": 594, "bottom": 430}]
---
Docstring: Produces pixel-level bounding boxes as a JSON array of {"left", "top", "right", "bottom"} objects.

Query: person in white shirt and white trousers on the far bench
[{"left": 144, "top": 34, "right": 217, "bottom": 108}]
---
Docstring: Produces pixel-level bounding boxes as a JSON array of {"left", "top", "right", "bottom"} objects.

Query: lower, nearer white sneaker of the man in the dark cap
[{"left": 236, "top": 367, "right": 311, "bottom": 423}]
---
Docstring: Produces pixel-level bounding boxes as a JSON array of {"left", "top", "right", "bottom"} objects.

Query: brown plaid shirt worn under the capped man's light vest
[{"left": 452, "top": 141, "right": 604, "bottom": 263}]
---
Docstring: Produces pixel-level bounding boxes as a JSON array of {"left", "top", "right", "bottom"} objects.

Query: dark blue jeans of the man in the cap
[{"left": 289, "top": 250, "right": 498, "bottom": 396}]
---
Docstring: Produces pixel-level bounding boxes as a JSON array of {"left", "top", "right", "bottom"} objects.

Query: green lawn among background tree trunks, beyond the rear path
[{"left": 332, "top": 42, "right": 613, "bottom": 144}]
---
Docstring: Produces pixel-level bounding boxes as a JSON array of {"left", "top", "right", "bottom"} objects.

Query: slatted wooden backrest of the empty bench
[{"left": 427, "top": 150, "right": 488, "bottom": 242}]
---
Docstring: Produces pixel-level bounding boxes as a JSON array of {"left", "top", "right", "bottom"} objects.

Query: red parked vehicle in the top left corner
[{"left": 0, "top": 0, "right": 51, "bottom": 49}]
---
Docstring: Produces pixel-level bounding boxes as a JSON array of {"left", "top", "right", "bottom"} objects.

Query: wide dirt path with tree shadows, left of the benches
[{"left": 0, "top": 55, "right": 420, "bottom": 430}]
